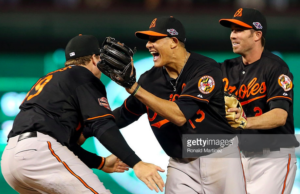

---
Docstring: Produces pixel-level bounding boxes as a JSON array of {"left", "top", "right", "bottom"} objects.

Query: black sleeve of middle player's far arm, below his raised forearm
[{"left": 113, "top": 96, "right": 147, "bottom": 129}]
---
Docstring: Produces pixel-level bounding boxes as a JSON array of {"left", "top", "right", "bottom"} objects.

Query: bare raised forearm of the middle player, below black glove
[{"left": 127, "top": 85, "right": 186, "bottom": 126}]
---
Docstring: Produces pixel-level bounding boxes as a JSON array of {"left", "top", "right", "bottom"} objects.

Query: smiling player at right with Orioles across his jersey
[{"left": 220, "top": 8, "right": 299, "bottom": 194}]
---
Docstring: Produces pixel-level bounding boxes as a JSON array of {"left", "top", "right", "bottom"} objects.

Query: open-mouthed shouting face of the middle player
[{"left": 146, "top": 36, "right": 172, "bottom": 67}]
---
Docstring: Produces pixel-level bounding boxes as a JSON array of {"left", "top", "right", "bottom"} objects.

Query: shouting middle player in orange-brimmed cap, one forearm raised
[{"left": 99, "top": 16, "right": 246, "bottom": 194}]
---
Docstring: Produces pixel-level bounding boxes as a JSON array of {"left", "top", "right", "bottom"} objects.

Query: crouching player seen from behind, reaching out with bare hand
[{"left": 1, "top": 35, "right": 164, "bottom": 194}]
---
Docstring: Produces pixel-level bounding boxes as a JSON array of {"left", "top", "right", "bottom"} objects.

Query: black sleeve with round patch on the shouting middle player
[{"left": 175, "top": 63, "right": 223, "bottom": 120}]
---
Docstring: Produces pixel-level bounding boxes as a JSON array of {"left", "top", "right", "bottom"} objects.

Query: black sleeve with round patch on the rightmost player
[{"left": 266, "top": 64, "right": 294, "bottom": 103}]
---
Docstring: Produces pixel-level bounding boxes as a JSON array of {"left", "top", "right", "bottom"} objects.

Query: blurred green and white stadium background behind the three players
[{"left": 0, "top": 0, "right": 300, "bottom": 194}]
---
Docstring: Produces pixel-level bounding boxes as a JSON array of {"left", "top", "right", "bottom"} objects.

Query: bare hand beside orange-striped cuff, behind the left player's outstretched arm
[{"left": 102, "top": 154, "right": 129, "bottom": 173}]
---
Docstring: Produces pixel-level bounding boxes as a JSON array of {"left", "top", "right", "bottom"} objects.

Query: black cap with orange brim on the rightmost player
[{"left": 219, "top": 8, "right": 267, "bottom": 37}]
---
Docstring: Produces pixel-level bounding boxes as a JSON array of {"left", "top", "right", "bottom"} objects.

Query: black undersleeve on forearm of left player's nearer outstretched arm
[{"left": 96, "top": 126, "right": 141, "bottom": 168}]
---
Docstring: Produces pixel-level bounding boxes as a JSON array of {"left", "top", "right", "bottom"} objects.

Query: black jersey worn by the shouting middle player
[{"left": 113, "top": 53, "right": 236, "bottom": 158}]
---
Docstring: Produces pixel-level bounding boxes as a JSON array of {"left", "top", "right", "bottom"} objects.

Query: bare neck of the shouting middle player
[{"left": 165, "top": 49, "right": 190, "bottom": 79}]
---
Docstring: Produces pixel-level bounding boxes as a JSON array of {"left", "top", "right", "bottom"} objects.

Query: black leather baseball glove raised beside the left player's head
[{"left": 97, "top": 37, "right": 136, "bottom": 88}]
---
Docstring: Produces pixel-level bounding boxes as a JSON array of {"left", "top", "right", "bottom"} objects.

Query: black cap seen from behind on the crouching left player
[{"left": 65, "top": 34, "right": 100, "bottom": 60}]
